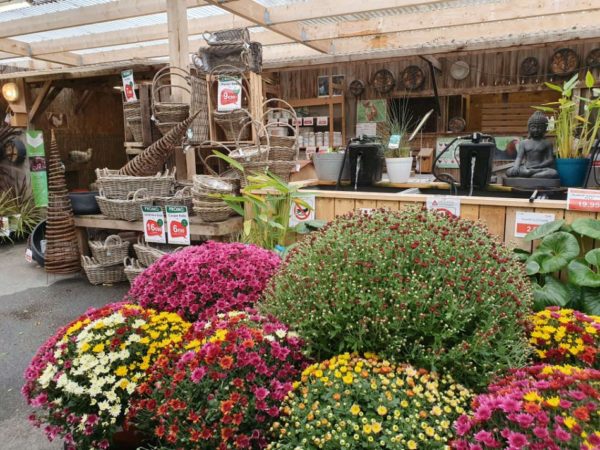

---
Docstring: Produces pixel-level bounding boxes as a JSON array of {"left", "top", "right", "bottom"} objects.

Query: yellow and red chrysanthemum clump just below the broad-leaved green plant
[{"left": 529, "top": 307, "right": 600, "bottom": 369}]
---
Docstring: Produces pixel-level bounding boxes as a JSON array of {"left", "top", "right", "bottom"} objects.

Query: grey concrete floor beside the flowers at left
[{"left": 0, "top": 244, "right": 129, "bottom": 450}]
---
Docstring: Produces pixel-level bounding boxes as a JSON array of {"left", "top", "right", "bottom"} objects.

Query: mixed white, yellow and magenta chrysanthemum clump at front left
[{"left": 22, "top": 303, "right": 191, "bottom": 449}]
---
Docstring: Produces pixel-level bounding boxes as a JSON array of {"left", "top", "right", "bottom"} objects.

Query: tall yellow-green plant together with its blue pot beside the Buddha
[{"left": 534, "top": 71, "right": 600, "bottom": 187}]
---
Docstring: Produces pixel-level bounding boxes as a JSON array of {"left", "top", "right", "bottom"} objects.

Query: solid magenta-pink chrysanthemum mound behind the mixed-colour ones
[{"left": 126, "top": 241, "right": 280, "bottom": 322}]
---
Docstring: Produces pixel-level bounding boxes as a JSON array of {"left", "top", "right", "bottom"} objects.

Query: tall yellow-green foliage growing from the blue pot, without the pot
[{"left": 534, "top": 71, "right": 600, "bottom": 158}]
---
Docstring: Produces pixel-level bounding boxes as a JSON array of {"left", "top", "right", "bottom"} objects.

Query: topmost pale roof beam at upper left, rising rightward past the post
[{"left": 0, "top": 0, "right": 206, "bottom": 37}]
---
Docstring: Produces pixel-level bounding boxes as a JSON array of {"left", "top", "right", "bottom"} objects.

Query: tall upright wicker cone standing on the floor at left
[{"left": 44, "top": 131, "right": 81, "bottom": 274}]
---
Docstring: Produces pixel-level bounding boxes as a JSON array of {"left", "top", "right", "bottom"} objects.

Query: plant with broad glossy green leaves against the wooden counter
[{"left": 515, "top": 218, "right": 600, "bottom": 315}]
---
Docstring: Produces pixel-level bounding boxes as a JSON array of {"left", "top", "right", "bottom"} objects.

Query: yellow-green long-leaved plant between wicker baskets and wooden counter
[{"left": 214, "top": 151, "right": 325, "bottom": 250}]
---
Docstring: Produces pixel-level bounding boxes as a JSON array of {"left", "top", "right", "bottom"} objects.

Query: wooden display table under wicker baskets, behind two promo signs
[{"left": 75, "top": 214, "right": 243, "bottom": 255}]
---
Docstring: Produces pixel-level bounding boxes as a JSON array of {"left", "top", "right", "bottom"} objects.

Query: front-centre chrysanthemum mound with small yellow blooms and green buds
[{"left": 268, "top": 353, "right": 472, "bottom": 450}]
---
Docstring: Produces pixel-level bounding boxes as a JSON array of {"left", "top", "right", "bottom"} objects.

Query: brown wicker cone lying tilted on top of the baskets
[{"left": 119, "top": 111, "right": 200, "bottom": 177}]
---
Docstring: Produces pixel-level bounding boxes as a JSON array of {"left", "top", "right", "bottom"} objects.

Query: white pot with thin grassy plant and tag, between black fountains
[{"left": 384, "top": 98, "right": 413, "bottom": 183}]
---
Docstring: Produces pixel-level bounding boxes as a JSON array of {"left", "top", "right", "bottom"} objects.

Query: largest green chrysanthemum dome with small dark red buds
[{"left": 260, "top": 209, "right": 531, "bottom": 387}]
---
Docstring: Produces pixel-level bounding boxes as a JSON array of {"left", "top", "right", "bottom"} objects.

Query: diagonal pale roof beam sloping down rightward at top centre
[{"left": 207, "top": 0, "right": 330, "bottom": 53}]
